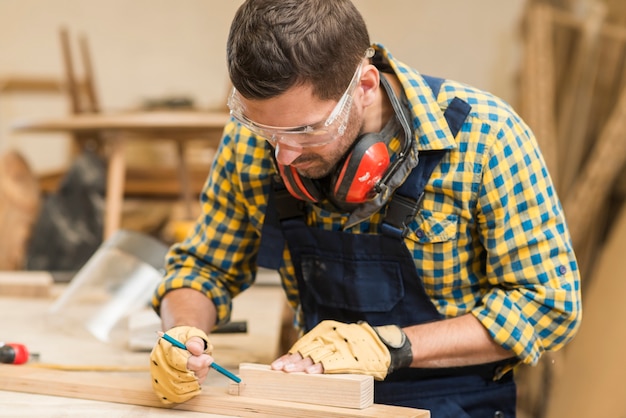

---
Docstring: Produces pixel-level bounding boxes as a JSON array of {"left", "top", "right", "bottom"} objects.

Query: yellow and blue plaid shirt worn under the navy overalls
[{"left": 153, "top": 45, "right": 581, "bottom": 364}]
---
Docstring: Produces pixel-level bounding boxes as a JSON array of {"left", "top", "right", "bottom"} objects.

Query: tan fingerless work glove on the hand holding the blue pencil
[{"left": 150, "top": 326, "right": 213, "bottom": 404}]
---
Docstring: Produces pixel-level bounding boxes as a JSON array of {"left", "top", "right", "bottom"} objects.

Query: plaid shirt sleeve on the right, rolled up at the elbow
[{"left": 472, "top": 112, "right": 581, "bottom": 364}]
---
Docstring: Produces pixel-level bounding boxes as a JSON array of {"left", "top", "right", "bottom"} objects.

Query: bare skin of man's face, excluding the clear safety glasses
[{"left": 238, "top": 85, "right": 363, "bottom": 178}]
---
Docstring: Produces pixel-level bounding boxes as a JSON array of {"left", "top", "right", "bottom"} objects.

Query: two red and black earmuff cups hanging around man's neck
[{"left": 278, "top": 133, "right": 390, "bottom": 204}]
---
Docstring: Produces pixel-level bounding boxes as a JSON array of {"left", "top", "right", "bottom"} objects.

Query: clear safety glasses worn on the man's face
[{"left": 228, "top": 48, "right": 374, "bottom": 147}]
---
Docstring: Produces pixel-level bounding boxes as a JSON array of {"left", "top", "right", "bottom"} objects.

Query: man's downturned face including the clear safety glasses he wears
[{"left": 228, "top": 52, "right": 374, "bottom": 178}]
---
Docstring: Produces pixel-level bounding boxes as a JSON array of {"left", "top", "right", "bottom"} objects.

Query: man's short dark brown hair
[{"left": 227, "top": 0, "right": 370, "bottom": 100}]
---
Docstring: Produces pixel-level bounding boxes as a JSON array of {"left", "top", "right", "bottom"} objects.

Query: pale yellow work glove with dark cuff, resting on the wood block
[{"left": 289, "top": 321, "right": 413, "bottom": 380}]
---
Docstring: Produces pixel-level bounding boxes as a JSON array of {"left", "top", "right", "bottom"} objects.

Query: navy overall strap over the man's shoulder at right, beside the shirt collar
[{"left": 381, "top": 75, "right": 472, "bottom": 237}]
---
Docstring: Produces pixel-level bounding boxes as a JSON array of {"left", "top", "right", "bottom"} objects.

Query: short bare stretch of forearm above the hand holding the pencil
[{"left": 161, "top": 288, "right": 217, "bottom": 334}]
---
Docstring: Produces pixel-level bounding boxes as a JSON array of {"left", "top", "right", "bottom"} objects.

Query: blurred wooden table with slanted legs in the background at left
[{"left": 13, "top": 110, "right": 230, "bottom": 239}]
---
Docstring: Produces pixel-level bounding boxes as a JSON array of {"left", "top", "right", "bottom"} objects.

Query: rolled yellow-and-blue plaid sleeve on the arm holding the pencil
[{"left": 152, "top": 122, "right": 267, "bottom": 324}]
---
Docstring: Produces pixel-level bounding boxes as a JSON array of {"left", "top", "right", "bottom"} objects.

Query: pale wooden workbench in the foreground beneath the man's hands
[{"left": 0, "top": 271, "right": 430, "bottom": 418}]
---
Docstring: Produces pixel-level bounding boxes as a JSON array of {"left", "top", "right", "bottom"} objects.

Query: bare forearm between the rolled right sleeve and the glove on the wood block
[{"left": 403, "top": 314, "right": 514, "bottom": 368}]
